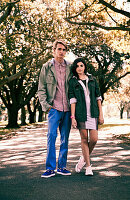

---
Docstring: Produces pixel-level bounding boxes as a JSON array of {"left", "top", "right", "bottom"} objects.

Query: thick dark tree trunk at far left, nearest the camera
[{"left": 6, "top": 105, "right": 19, "bottom": 128}]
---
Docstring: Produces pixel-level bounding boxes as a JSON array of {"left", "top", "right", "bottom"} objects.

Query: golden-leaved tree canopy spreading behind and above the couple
[{"left": 0, "top": 0, "right": 129, "bottom": 126}]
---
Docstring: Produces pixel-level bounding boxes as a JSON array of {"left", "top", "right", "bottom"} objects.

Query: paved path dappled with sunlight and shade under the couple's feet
[{"left": 0, "top": 123, "right": 130, "bottom": 200}]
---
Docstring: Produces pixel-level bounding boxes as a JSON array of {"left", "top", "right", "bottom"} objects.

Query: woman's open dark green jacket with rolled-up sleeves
[{"left": 68, "top": 75, "right": 101, "bottom": 122}]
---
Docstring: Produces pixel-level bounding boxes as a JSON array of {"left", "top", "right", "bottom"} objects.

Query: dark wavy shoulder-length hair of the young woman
[{"left": 71, "top": 58, "right": 87, "bottom": 78}]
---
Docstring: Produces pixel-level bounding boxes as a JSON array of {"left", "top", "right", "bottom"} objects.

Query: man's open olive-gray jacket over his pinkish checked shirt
[{"left": 38, "top": 58, "right": 71, "bottom": 112}]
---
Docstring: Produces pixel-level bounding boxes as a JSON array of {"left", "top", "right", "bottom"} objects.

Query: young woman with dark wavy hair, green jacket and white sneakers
[{"left": 69, "top": 58, "right": 104, "bottom": 175}]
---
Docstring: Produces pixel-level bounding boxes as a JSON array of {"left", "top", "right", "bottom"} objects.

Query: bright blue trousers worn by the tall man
[{"left": 46, "top": 108, "right": 71, "bottom": 170}]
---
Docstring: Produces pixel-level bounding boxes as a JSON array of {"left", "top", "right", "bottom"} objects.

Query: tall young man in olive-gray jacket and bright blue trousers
[{"left": 38, "top": 40, "right": 71, "bottom": 178}]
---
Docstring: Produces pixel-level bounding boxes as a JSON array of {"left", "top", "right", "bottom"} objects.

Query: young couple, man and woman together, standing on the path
[{"left": 38, "top": 40, "right": 104, "bottom": 178}]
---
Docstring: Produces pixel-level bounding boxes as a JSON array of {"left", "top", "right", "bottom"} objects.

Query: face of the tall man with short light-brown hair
[{"left": 54, "top": 44, "right": 66, "bottom": 59}]
